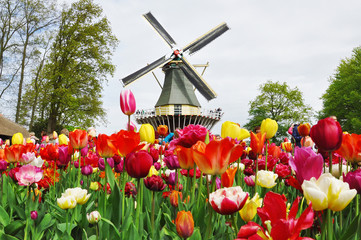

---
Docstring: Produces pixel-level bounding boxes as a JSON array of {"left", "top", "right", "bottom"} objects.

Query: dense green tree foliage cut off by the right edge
[{"left": 319, "top": 47, "right": 361, "bottom": 134}]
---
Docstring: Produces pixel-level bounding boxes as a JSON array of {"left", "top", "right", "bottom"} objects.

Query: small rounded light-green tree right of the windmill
[{"left": 245, "top": 81, "right": 312, "bottom": 142}]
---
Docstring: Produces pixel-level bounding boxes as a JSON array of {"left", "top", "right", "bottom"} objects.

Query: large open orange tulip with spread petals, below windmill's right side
[{"left": 192, "top": 138, "right": 243, "bottom": 175}]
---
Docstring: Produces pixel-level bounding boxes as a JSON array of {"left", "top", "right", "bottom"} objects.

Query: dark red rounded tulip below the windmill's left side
[{"left": 125, "top": 150, "right": 153, "bottom": 178}]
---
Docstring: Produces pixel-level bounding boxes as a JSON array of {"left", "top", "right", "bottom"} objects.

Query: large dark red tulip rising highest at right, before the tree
[{"left": 310, "top": 118, "right": 343, "bottom": 152}]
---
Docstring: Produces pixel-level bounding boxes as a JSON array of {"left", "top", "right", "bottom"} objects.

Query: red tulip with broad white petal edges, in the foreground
[{"left": 209, "top": 186, "right": 248, "bottom": 215}]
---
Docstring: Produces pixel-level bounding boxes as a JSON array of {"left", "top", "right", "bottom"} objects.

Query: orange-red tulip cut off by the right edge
[{"left": 336, "top": 133, "right": 361, "bottom": 162}]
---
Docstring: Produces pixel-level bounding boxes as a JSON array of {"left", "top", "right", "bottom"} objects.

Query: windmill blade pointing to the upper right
[{"left": 183, "top": 23, "right": 229, "bottom": 54}]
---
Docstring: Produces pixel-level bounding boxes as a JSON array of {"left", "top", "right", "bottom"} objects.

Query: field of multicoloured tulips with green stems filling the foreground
[{"left": 0, "top": 117, "right": 361, "bottom": 240}]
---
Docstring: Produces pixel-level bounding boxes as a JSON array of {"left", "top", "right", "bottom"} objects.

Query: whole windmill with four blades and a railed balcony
[{"left": 122, "top": 12, "right": 229, "bottom": 131}]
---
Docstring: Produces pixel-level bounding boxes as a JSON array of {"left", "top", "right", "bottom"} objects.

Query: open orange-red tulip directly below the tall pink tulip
[{"left": 112, "top": 130, "right": 140, "bottom": 157}]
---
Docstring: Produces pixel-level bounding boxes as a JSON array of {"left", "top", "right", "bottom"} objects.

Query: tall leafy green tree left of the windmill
[{"left": 40, "top": 0, "right": 118, "bottom": 131}]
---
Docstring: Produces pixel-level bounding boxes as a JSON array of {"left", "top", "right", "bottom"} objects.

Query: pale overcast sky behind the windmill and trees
[{"left": 62, "top": 0, "right": 361, "bottom": 134}]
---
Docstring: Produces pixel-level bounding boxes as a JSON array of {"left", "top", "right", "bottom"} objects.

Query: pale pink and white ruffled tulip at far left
[{"left": 15, "top": 165, "right": 43, "bottom": 186}]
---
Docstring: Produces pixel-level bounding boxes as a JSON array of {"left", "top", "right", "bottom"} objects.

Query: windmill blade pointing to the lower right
[{"left": 179, "top": 57, "right": 217, "bottom": 101}]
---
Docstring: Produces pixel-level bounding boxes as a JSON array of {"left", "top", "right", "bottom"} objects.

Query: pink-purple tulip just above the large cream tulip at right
[{"left": 289, "top": 147, "right": 323, "bottom": 185}]
